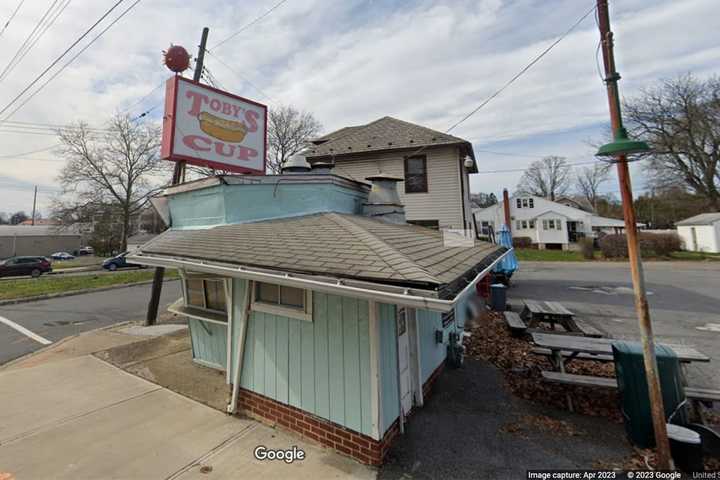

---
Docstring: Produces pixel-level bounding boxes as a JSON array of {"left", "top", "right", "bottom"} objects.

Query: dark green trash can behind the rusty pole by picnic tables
[{"left": 612, "top": 341, "right": 688, "bottom": 448}]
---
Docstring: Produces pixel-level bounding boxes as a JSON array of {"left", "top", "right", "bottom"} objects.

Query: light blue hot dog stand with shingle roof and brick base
[{"left": 128, "top": 169, "right": 507, "bottom": 464}]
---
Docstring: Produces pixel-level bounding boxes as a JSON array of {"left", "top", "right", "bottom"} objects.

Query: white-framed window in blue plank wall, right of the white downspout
[{"left": 252, "top": 282, "right": 312, "bottom": 321}]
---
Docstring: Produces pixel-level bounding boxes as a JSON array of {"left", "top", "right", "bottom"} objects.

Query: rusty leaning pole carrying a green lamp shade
[{"left": 597, "top": 0, "right": 673, "bottom": 470}]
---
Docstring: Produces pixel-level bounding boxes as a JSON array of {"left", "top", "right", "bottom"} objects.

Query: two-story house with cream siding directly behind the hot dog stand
[{"left": 306, "top": 117, "right": 477, "bottom": 230}]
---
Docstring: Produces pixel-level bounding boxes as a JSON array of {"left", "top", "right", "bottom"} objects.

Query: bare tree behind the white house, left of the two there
[{"left": 517, "top": 156, "right": 571, "bottom": 201}]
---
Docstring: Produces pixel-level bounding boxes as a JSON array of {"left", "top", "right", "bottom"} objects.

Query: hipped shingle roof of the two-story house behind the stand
[{"left": 306, "top": 117, "right": 472, "bottom": 159}]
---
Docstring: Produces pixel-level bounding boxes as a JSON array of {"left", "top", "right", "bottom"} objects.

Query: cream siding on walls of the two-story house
[{"left": 333, "top": 147, "right": 470, "bottom": 228}]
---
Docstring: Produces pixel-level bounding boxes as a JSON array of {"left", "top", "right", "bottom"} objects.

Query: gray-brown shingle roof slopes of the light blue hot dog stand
[{"left": 140, "top": 213, "right": 505, "bottom": 286}]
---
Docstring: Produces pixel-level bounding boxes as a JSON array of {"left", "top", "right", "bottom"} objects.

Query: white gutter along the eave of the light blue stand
[{"left": 127, "top": 249, "right": 513, "bottom": 312}]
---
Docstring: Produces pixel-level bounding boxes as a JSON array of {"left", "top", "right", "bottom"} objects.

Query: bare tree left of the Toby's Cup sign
[{"left": 56, "top": 114, "right": 168, "bottom": 250}]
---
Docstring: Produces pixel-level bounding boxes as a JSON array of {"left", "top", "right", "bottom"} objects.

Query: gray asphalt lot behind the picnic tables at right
[{"left": 508, "top": 262, "right": 720, "bottom": 388}]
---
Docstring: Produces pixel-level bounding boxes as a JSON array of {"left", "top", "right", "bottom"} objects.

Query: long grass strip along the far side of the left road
[{"left": 0, "top": 269, "right": 178, "bottom": 300}]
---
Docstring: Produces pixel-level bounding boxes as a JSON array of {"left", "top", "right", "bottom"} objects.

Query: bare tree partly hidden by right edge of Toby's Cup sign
[{"left": 268, "top": 105, "right": 322, "bottom": 173}]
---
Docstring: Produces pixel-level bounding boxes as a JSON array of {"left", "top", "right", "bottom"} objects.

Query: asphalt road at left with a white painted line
[{"left": 0, "top": 280, "right": 181, "bottom": 365}]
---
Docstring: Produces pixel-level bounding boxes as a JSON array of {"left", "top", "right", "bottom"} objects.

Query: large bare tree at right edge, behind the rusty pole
[{"left": 624, "top": 75, "right": 720, "bottom": 210}]
